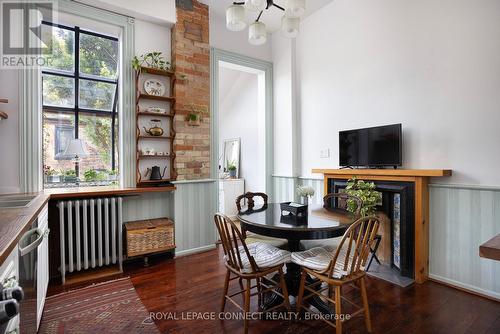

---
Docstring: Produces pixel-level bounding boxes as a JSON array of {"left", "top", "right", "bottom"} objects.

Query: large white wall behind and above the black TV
[{"left": 273, "top": 0, "right": 500, "bottom": 186}]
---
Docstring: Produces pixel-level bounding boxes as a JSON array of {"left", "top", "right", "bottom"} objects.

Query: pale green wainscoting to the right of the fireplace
[{"left": 429, "top": 184, "right": 500, "bottom": 299}]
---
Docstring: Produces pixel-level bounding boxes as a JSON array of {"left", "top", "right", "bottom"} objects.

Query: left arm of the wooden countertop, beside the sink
[{"left": 0, "top": 193, "right": 50, "bottom": 264}]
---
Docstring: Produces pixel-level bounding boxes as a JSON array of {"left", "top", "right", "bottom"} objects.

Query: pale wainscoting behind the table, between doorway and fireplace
[{"left": 273, "top": 175, "right": 324, "bottom": 204}]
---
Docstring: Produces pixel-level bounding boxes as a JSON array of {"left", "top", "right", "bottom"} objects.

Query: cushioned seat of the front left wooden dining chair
[{"left": 231, "top": 242, "right": 291, "bottom": 273}]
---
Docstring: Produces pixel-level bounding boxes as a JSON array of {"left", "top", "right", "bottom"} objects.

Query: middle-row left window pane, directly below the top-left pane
[{"left": 42, "top": 74, "right": 75, "bottom": 108}]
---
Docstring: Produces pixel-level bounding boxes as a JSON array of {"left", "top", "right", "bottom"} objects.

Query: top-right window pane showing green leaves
[{"left": 80, "top": 33, "right": 118, "bottom": 79}]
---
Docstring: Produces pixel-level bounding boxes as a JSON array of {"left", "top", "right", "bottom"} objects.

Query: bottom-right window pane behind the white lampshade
[{"left": 78, "top": 114, "right": 118, "bottom": 175}]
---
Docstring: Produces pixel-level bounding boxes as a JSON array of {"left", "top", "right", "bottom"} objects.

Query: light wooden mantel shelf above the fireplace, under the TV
[{"left": 312, "top": 168, "right": 452, "bottom": 177}]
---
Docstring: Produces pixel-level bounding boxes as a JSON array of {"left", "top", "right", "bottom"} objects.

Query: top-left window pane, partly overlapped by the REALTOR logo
[{"left": 42, "top": 24, "right": 75, "bottom": 73}]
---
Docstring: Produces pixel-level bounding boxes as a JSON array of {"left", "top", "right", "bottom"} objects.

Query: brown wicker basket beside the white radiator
[{"left": 125, "top": 218, "right": 175, "bottom": 257}]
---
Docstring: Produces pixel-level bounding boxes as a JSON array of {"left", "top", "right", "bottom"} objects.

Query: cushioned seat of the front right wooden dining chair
[{"left": 292, "top": 245, "right": 364, "bottom": 279}]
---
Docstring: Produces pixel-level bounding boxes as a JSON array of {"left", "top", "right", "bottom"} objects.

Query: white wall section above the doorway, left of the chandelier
[{"left": 210, "top": 10, "right": 272, "bottom": 61}]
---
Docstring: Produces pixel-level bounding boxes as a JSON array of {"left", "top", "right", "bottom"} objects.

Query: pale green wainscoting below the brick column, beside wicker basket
[{"left": 174, "top": 180, "right": 217, "bottom": 255}]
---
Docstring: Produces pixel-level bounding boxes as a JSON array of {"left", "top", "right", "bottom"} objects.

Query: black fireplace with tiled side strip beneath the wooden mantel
[{"left": 327, "top": 178, "right": 415, "bottom": 279}]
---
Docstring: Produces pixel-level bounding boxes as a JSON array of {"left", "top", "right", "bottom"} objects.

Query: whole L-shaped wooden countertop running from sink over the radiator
[{"left": 0, "top": 185, "right": 176, "bottom": 264}]
